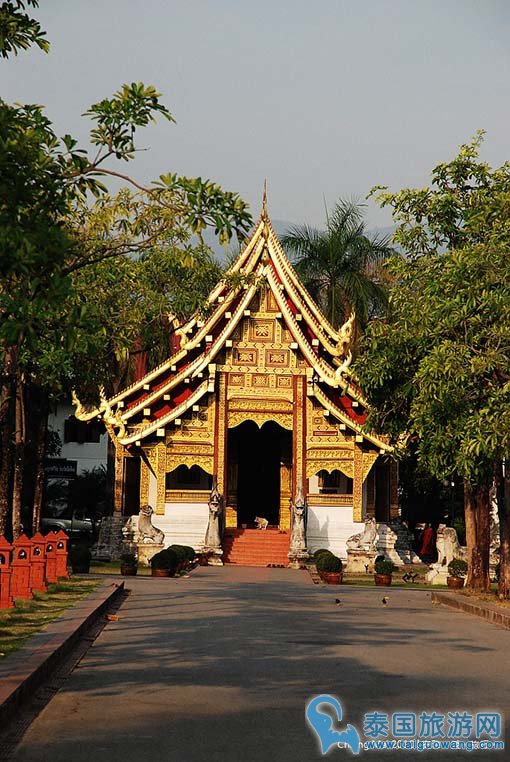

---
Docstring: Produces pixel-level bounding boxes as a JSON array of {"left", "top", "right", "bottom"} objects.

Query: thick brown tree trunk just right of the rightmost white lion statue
[{"left": 464, "top": 484, "right": 490, "bottom": 592}]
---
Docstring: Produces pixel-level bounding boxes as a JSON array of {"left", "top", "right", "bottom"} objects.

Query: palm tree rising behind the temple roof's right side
[{"left": 281, "top": 199, "right": 396, "bottom": 328}]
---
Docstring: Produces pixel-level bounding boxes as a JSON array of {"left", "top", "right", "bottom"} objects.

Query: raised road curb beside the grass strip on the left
[{"left": 0, "top": 582, "right": 124, "bottom": 728}]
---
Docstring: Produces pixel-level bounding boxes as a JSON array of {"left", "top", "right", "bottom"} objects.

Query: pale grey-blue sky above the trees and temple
[{"left": 0, "top": 0, "right": 510, "bottom": 226}]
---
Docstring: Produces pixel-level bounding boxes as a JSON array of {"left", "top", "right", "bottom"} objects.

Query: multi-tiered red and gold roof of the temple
[{"left": 75, "top": 200, "right": 389, "bottom": 450}]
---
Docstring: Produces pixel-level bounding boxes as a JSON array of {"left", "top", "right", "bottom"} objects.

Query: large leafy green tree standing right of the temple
[{"left": 355, "top": 135, "right": 510, "bottom": 597}]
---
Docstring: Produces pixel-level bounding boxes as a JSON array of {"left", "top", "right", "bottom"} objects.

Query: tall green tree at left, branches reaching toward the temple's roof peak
[{"left": 0, "top": 7, "right": 251, "bottom": 537}]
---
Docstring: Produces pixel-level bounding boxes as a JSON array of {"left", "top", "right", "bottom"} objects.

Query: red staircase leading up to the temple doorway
[{"left": 223, "top": 528, "right": 290, "bottom": 566}]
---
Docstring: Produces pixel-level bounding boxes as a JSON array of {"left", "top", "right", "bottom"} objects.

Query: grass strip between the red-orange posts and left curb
[{"left": 0, "top": 579, "right": 101, "bottom": 658}]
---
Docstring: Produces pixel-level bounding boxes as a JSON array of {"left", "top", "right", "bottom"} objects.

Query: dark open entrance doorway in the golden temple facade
[{"left": 227, "top": 421, "right": 292, "bottom": 528}]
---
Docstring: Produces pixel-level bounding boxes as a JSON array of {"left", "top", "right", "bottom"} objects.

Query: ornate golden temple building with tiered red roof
[{"left": 76, "top": 201, "right": 397, "bottom": 564}]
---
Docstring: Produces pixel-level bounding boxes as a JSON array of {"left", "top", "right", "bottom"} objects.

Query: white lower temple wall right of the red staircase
[{"left": 306, "top": 505, "right": 365, "bottom": 559}]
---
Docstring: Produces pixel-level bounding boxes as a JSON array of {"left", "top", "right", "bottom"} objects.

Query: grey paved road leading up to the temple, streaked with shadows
[{"left": 9, "top": 567, "right": 510, "bottom": 762}]
